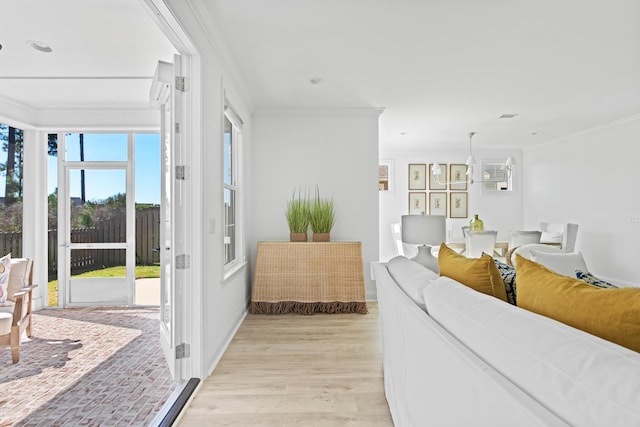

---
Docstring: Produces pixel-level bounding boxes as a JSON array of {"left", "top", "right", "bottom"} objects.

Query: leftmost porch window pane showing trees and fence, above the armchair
[{"left": 0, "top": 124, "right": 24, "bottom": 258}]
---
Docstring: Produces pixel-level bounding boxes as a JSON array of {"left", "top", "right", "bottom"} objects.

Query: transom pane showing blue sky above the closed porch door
[{"left": 65, "top": 133, "right": 127, "bottom": 162}]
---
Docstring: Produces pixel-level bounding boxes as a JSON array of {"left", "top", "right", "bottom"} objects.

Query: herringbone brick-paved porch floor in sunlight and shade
[{"left": 0, "top": 307, "right": 175, "bottom": 427}]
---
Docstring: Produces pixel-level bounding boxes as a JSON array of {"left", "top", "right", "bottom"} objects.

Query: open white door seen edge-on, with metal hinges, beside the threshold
[{"left": 156, "top": 55, "right": 191, "bottom": 382}]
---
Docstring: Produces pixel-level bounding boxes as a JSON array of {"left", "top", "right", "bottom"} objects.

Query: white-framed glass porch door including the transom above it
[{"left": 58, "top": 133, "right": 135, "bottom": 307}]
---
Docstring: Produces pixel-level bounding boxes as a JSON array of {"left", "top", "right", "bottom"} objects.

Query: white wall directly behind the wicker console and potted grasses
[{"left": 247, "top": 109, "right": 380, "bottom": 299}]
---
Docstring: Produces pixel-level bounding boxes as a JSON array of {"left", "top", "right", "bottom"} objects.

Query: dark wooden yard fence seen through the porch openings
[{"left": 0, "top": 207, "right": 160, "bottom": 279}]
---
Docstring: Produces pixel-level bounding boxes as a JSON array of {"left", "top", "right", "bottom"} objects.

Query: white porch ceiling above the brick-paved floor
[{"left": 0, "top": 0, "right": 175, "bottom": 109}]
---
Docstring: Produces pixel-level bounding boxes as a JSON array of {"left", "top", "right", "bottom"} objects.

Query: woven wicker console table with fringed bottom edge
[{"left": 250, "top": 242, "right": 367, "bottom": 314}]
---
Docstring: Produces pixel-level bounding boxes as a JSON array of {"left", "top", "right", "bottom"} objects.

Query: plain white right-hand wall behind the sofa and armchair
[{"left": 524, "top": 117, "right": 640, "bottom": 284}]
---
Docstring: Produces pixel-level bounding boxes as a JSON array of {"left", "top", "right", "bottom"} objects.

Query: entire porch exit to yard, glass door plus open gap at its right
[{"left": 48, "top": 132, "right": 160, "bottom": 307}]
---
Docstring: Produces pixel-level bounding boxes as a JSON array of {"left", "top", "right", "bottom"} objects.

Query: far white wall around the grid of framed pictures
[{"left": 379, "top": 149, "right": 524, "bottom": 261}]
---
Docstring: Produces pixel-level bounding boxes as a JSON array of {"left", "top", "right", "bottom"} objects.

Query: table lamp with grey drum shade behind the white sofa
[{"left": 402, "top": 215, "right": 447, "bottom": 273}]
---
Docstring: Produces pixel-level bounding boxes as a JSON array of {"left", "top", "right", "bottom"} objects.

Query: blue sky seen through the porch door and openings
[{"left": 47, "top": 133, "right": 160, "bottom": 204}]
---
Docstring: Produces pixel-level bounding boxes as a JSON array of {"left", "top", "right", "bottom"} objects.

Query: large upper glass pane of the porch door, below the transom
[{"left": 69, "top": 169, "right": 126, "bottom": 243}]
